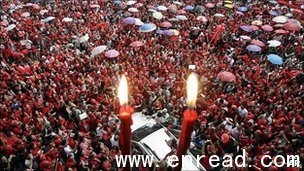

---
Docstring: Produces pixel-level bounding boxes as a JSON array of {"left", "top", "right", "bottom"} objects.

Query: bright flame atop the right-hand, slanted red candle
[{"left": 187, "top": 73, "right": 198, "bottom": 108}]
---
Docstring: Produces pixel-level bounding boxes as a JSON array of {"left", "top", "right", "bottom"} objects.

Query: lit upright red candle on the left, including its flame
[{"left": 118, "top": 76, "right": 134, "bottom": 171}]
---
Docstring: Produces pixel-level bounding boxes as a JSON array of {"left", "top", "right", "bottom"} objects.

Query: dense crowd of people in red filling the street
[{"left": 0, "top": 0, "right": 304, "bottom": 171}]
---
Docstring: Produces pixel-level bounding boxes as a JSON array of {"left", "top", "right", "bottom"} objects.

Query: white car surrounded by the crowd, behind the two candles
[{"left": 131, "top": 112, "right": 205, "bottom": 171}]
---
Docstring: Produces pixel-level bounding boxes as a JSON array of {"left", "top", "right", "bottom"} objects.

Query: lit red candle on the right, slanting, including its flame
[{"left": 175, "top": 73, "right": 198, "bottom": 171}]
